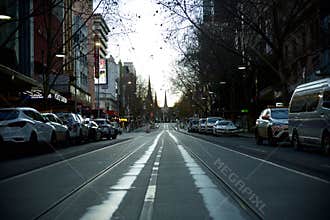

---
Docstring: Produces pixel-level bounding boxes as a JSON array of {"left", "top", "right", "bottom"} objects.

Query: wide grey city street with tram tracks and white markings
[{"left": 0, "top": 123, "right": 330, "bottom": 220}]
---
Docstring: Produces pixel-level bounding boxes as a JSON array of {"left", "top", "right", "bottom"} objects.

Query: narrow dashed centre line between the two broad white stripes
[{"left": 139, "top": 139, "right": 164, "bottom": 220}]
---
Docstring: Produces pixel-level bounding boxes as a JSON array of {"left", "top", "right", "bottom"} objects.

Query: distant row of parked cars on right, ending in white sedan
[{"left": 187, "top": 117, "right": 241, "bottom": 135}]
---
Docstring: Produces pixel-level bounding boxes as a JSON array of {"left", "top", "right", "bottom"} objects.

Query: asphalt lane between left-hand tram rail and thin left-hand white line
[{"left": 0, "top": 132, "right": 156, "bottom": 219}]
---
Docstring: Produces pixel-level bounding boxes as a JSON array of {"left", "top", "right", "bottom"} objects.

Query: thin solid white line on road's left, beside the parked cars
[{"left": 0, "top": 139, "right": 133, "bottom": 184}]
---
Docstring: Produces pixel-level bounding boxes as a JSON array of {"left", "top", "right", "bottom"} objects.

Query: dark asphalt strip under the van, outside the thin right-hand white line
[{"left": 180, "top": 130, "right": 330, "bottom": 182}]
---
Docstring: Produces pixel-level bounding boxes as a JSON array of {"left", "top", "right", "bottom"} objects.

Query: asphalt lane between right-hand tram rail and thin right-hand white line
[{"left": 171, "top": 129, "right": 330, "bottom": 219}]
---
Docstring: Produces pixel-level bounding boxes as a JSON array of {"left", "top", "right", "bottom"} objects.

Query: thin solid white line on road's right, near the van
[{"left": 179, "top": 131, "right": 330, "bottom": 184}]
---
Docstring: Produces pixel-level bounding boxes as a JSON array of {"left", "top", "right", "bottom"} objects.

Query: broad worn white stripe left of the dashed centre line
[{"left": 80, "top": 132, "right": 163, "bottom": 220}]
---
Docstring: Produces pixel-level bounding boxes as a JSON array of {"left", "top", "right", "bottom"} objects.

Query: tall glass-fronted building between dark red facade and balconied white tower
[{"left": 55, "top": 0, "right": 94, "bottom": 113}]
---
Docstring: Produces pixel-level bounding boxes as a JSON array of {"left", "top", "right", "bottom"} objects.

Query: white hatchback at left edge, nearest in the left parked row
[{"left": 0, "top": 107, "right": 57, "bottom": 145}]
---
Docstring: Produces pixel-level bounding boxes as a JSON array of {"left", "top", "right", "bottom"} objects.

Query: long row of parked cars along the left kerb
[{"left": 0, "top": 107, "right": 119, "bottom": 146}]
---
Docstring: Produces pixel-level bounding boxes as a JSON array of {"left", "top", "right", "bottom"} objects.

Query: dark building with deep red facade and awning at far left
[{"left": 0, "top": 0, "right": 67, "bottom": 110}]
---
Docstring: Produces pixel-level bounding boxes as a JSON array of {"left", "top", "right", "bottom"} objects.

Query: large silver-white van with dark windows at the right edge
[{"left": 289, "top": 78, "right": 330, "bottom": 154}]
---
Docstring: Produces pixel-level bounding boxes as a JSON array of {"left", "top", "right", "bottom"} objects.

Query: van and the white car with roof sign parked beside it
[{"left": 255, "top": 78, "right": 330, "bottom": 154}]
